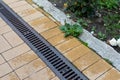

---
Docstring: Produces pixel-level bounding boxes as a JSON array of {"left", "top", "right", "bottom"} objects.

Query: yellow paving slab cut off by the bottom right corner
[{"left": 96, "top": 68, "right": 120, "bottom": 80}]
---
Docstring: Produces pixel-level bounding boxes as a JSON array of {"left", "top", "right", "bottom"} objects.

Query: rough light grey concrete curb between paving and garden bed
[{"left": 33, "top": 0, "right": 120, "bottom": 71}]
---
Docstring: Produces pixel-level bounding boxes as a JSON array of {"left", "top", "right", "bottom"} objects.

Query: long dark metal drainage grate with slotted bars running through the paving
[{"left": 0, "top": 1, "right": 88, "bottom": 80}]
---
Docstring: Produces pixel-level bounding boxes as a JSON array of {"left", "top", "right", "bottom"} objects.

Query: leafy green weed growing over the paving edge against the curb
[{"left": 60, "top": 23, "right": 83, "bottom": 38}]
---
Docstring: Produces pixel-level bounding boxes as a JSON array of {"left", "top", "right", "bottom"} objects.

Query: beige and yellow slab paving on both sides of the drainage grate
[{"left": 0, "top": 0, "right": 120, "bottom": 80}]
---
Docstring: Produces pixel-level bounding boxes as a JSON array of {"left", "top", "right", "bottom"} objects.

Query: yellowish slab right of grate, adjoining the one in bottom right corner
[{"left": 83, "top": 60, "right": 112, "bottom": 80}]
